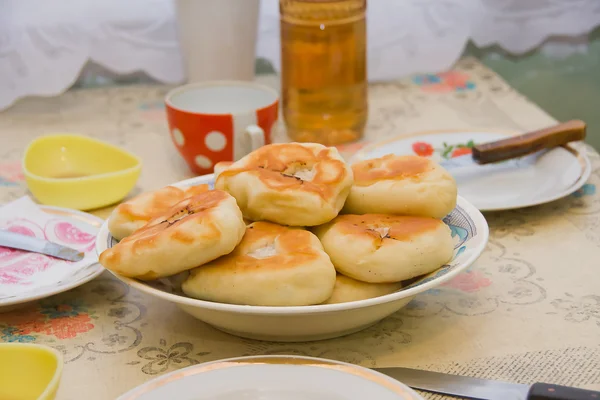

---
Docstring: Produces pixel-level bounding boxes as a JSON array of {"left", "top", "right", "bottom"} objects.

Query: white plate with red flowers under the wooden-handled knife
[{"left": 351, "top": 131, "right": 592, "bottom": 211}]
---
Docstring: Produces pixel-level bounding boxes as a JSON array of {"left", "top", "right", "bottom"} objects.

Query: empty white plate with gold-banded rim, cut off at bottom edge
[{"left": 117, "top": 356, "right": 423, "bottom": 400}]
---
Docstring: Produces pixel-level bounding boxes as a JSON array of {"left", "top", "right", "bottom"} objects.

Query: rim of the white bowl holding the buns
[{"left": 96, "top": 174, "right": 489, "bottom": 315}]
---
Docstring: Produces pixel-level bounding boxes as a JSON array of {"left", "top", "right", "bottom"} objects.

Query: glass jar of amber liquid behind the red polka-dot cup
[{"left": 279, "top": 0, "right": 368, "bottom": 146}]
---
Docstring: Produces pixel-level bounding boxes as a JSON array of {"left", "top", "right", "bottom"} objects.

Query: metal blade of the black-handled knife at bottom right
[{"left": 375, "top": 367, "right": 530, "bottom": 400}]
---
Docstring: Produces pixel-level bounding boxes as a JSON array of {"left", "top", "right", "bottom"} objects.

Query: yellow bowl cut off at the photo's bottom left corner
[{"left": 0, "top": 343, "right": 63, "bottom": 400}]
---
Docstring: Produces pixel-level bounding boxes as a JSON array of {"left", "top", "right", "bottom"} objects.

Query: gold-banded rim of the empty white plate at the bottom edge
[{"left": 117, "top": 355, "right": 423, "bottom": 400}]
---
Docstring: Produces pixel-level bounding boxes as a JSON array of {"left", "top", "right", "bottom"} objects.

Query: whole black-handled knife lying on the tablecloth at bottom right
[{"left": 374, "top": 367, "right": 600, "bottom": 400}]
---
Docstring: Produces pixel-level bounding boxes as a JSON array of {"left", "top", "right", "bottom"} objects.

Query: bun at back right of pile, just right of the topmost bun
[{"left": 343, "top": 154, "right": 457, "bottom": 218}]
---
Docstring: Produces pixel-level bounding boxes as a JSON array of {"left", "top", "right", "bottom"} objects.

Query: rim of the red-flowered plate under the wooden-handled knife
[{"left": 349, "top": 128, "right": 592, "bottom": 212}]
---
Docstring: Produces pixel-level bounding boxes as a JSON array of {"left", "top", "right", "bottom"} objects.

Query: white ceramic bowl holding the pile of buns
[{"left": 96, "top": 175, "right": 489, "bottom": 342}]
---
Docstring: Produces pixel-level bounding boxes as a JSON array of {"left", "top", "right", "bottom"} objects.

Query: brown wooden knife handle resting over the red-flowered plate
[{"left": 473, "top": 120, "right": 586, "bottom": 164}]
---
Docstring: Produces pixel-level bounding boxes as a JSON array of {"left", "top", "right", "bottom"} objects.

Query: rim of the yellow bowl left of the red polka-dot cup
[{"left": 21, "top": 133, "right": 142, "bottom": 182}]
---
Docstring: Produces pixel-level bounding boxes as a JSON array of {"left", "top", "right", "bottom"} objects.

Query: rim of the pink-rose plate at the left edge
[{"left": 0, "top": 205, "right": 104, "bottom": 314}]
